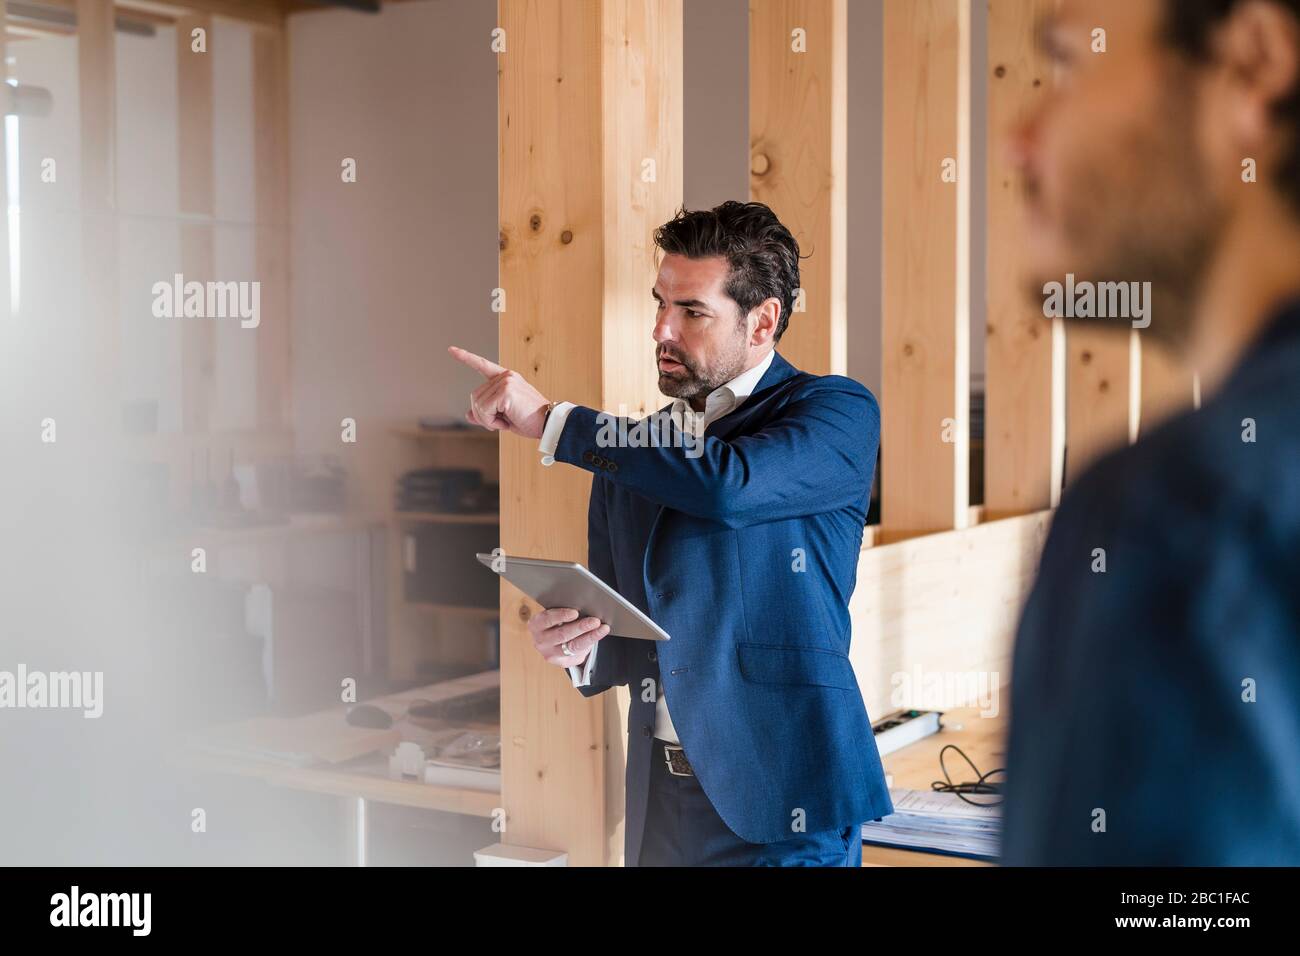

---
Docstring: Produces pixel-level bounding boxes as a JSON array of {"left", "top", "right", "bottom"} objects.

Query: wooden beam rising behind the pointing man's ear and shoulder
[{"left": 749, "top": 0, "right": 849, "bottom": 375}]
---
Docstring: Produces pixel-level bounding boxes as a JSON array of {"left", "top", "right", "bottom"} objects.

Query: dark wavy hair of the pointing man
[{"left": 654, "top": 200, "right": 800, "bottom": 342}]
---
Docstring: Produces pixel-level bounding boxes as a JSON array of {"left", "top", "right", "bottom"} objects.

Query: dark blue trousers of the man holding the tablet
[{"left": 627, "top": 739, "right": 862, "bottom": 866}]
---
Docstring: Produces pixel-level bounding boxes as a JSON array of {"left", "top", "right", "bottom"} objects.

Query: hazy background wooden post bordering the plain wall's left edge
[{"left": 252, "top": 29, "right": 293, "bottom": 428}]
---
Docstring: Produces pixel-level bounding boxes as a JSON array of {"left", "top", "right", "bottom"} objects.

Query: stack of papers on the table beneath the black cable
[{"left": 862, "top": 790, "right": 1002, "bottom": 860}]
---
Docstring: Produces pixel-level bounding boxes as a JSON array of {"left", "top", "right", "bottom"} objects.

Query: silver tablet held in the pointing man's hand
[{"left": 475, "top": 554, "right": 668, "bottom": 641}]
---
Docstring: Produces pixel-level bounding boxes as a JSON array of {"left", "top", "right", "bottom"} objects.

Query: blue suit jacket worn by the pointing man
[{"left": 555, "top": 355, "right": 893, "bottom": 865}]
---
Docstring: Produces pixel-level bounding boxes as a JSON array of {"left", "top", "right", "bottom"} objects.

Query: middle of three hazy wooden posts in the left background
[{"left": 176, "top": 14, "right": 216, "bottom": 434}]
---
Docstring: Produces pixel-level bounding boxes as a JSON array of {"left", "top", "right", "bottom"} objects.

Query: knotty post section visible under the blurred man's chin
[{"left": 1065, "top": 325, "right": 1141, "bottom": 484}]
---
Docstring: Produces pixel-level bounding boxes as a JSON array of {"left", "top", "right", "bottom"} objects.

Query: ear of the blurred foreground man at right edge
[{"left": 1218, "top": 0, "right": 1300, "bottom": 149}]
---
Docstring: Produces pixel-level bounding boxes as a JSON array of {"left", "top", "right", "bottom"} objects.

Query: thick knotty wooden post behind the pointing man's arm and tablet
[{"left": 485, "top": 0, "right": 683, "bottom": 865}]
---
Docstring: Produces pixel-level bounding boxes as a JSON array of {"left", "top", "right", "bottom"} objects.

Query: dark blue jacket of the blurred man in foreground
[{"left": 1002, "top": 303, "right": 1300, "bottom": 866}]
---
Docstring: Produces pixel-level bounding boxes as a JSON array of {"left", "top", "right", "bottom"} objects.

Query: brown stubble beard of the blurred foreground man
[{"left": 1023, "top": 68, "right": 1225, "bottom": 349}]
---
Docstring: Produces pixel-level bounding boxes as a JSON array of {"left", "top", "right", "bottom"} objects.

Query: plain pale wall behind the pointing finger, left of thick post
[{"left": 289, "top": 0, "right": 496, "bottom": 509}]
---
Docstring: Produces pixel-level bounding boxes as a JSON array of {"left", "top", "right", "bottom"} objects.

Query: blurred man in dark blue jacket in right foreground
[{"left": 1004, "top": 0, "right": 1300, "bottom": 866}]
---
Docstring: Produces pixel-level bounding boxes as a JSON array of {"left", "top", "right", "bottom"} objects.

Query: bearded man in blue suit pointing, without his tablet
[{"left": 452, "top": 203, "right": 893, "bottom": 866}]
